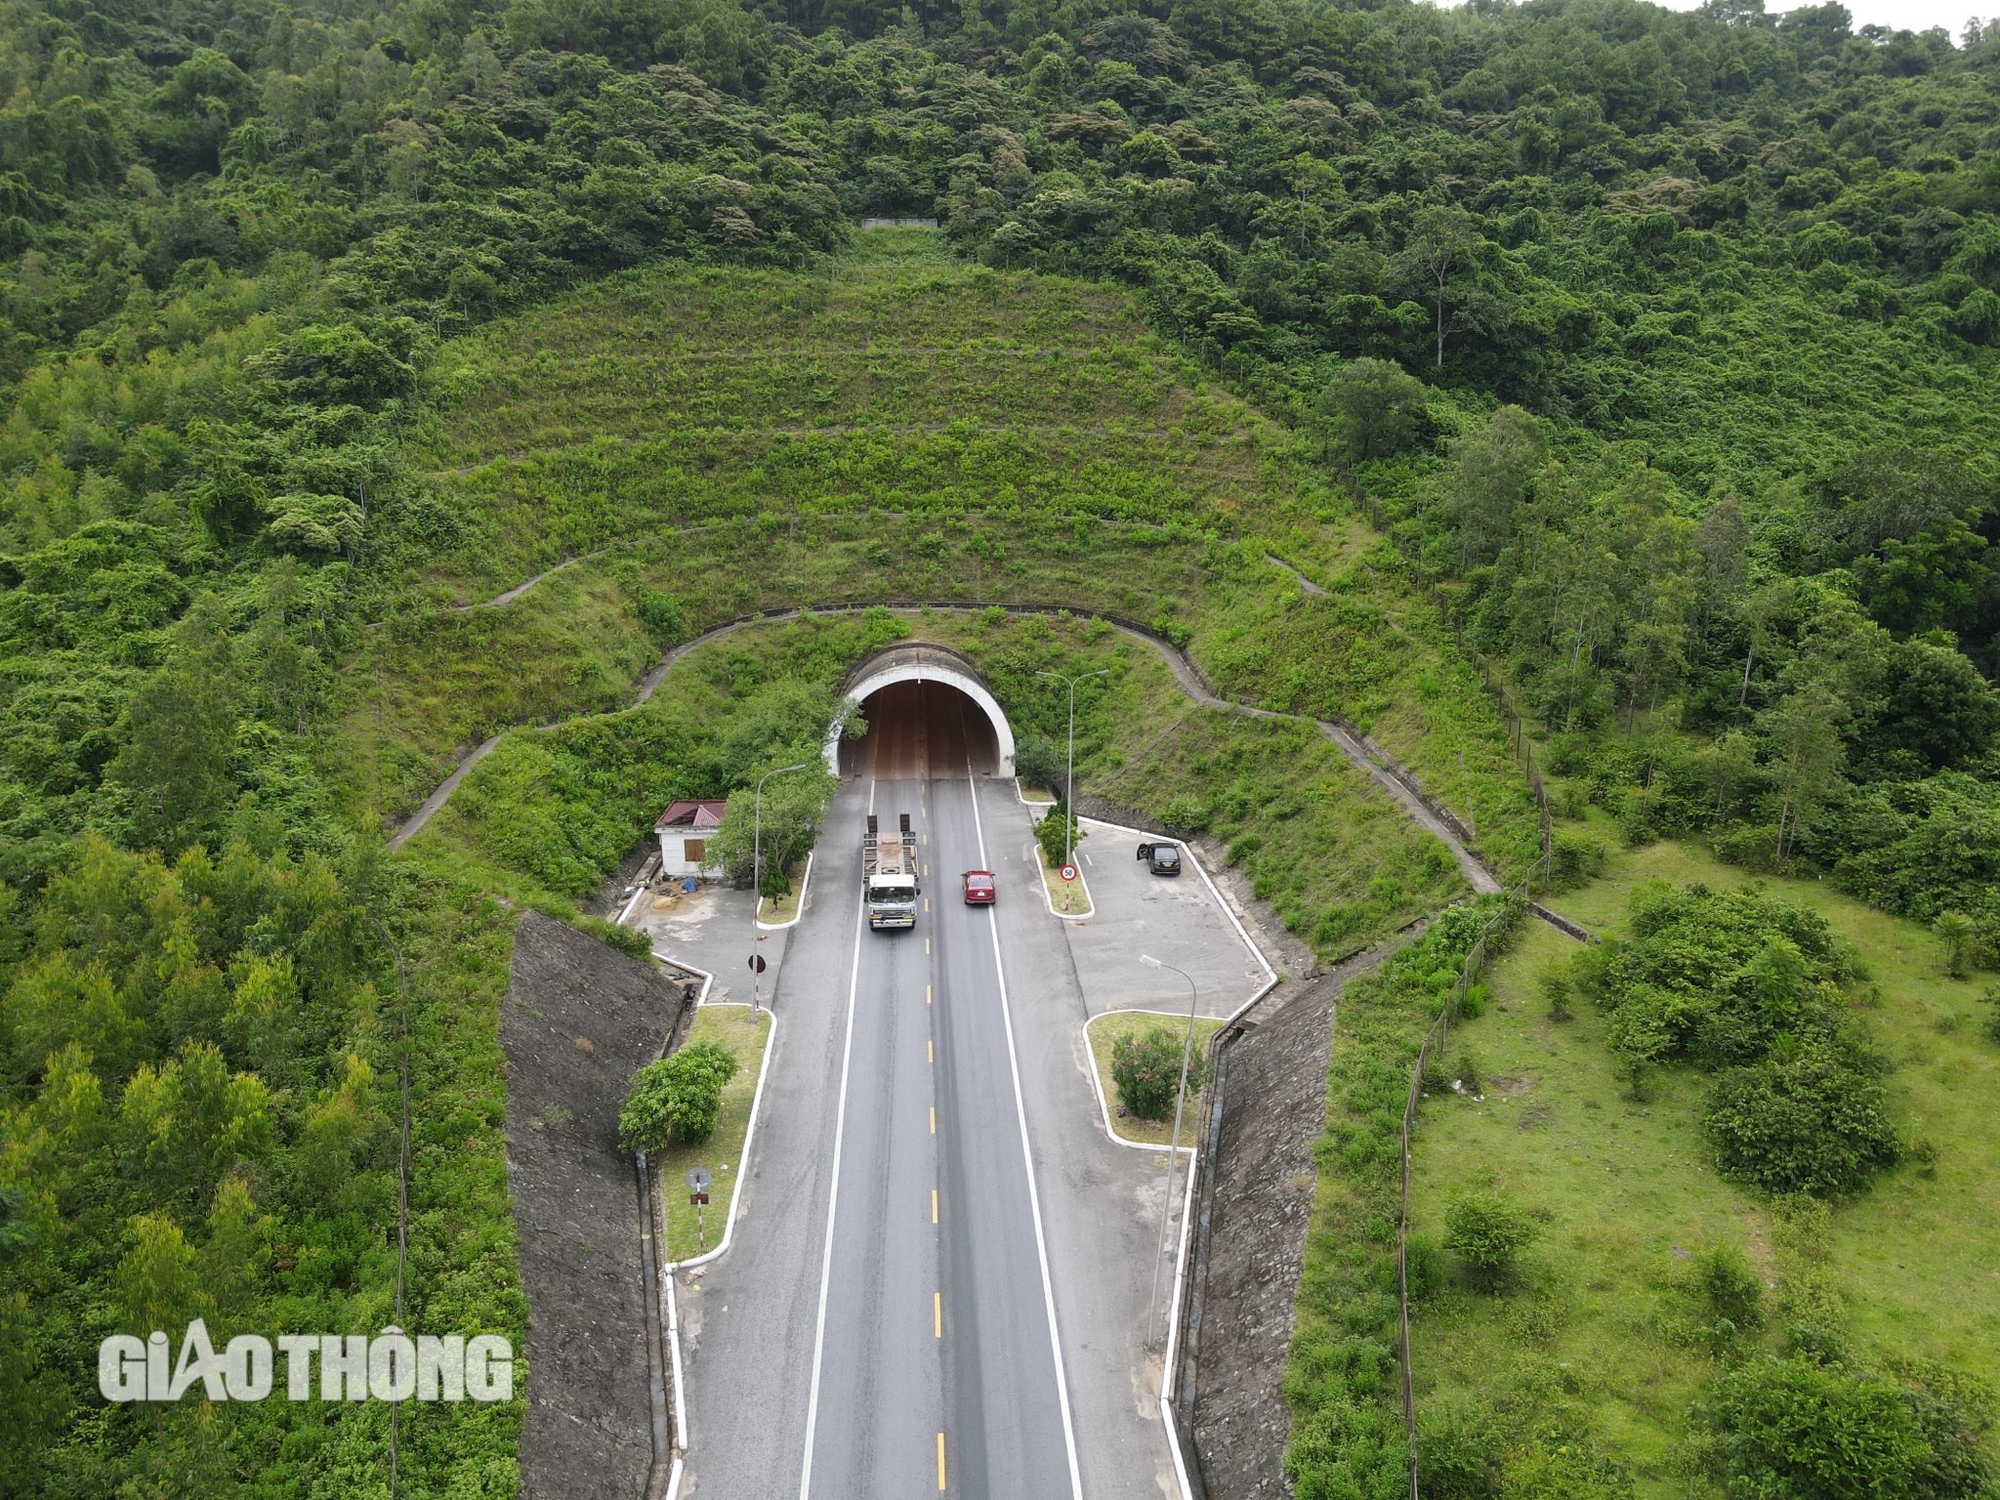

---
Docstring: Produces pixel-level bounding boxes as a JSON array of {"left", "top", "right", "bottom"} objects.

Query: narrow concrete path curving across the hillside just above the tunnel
[{"left": 390, "top": 584, "right": 1500, "bottom": 894}]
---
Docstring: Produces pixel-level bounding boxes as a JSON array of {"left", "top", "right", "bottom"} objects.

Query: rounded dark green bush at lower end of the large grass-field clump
[{"left": 1702, "top": 1044, "right": 1900, "bottom": 1196}]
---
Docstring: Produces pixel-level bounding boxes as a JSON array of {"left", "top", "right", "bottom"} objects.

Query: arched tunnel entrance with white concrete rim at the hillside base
[{"left": 826, "top": 644, "right": 1014, "bottom": 778}]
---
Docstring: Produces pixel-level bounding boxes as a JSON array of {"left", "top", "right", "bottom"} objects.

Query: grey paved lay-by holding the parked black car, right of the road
[{"left": 1064, "top": 818, "right": 1268, "bottom": 1016}]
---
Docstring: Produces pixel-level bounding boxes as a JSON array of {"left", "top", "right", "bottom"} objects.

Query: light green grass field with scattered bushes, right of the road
[{"left": 1412, "top": 844, "right": 2000, "bottom": 1498}]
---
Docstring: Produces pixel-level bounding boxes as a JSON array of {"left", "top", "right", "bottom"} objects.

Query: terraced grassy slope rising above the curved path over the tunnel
[{"left": 344, "top": 230, "right": 1532, "bottom": 904}]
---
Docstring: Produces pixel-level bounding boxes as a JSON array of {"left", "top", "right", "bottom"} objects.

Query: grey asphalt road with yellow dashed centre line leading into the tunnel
[{"left": 680, "top": 704, "right": 1178, "bottom": 1500}]
